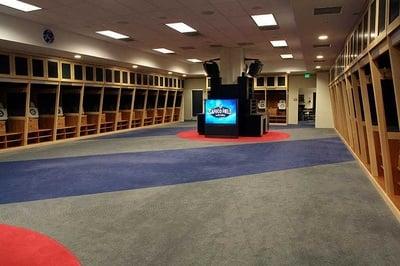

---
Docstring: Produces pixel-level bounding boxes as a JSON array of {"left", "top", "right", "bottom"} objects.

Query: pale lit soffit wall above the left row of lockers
[{"left": 0, "top": 14, "right": 190, "bottom": 73}]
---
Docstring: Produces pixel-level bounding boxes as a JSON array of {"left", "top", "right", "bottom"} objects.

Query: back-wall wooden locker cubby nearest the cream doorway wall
[{"left": 266, "top": 90, "right": 287, "bottom": 124}]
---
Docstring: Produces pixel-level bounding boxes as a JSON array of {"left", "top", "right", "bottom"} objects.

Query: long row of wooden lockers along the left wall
[{"left": 0, "top": 51, "right": 184, "bottom": 150}]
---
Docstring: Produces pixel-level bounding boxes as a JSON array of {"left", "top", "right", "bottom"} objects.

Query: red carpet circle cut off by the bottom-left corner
[{"left": 0, "top": 224, "right": 80, "bottom": 266}]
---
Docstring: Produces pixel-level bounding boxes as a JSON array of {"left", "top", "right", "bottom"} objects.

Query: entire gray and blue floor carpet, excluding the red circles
[{"left": 0, "top": 124, "right": 400, "bottom": 265}]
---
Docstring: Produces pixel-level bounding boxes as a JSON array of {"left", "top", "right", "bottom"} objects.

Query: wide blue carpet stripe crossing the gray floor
[{"left": 0, "top": 138, "right": 353, "bottom": 204}]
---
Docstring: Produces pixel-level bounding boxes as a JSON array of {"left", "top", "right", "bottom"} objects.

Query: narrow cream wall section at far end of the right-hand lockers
[{"left": 315, "top": 72, "right": 333, "bottom": 128}]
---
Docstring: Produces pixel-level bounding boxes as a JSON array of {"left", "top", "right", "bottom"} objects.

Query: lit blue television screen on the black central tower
[{"left": 205, "top": 99, "right": 237, "bottom": 125}]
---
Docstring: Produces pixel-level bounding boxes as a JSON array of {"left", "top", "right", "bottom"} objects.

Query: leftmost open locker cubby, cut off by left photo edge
[{"left": 0, "top": 83, "right": 27, "bottom": 149}]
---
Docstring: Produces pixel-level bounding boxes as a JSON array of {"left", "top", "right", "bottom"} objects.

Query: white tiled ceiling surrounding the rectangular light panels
[{"left": 0, "top": 0, "right": 367, "bottom": 72}]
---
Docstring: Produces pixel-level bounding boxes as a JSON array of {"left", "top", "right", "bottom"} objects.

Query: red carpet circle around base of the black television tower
[{"left": 177, "top": 130, "right": 290, "bottom": 143}]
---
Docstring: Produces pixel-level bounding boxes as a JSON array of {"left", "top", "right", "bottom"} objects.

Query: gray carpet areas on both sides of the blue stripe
[{"left": 0, "top": 124, "right": 400, "bottom": 266}]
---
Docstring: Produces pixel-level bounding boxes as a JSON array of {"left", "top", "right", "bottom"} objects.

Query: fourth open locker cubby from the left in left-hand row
[{"left": 80, "top": 86, "right": 101, "bottom": 136}]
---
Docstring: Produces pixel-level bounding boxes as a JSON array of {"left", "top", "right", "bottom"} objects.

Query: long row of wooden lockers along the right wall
[{"left": 330, "top": 0, "right": 400, "bottom": 212}]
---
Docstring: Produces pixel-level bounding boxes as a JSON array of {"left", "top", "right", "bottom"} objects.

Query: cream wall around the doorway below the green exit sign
[{"left": 288, "top": 75, "right": 318, "bottom": 124}]
